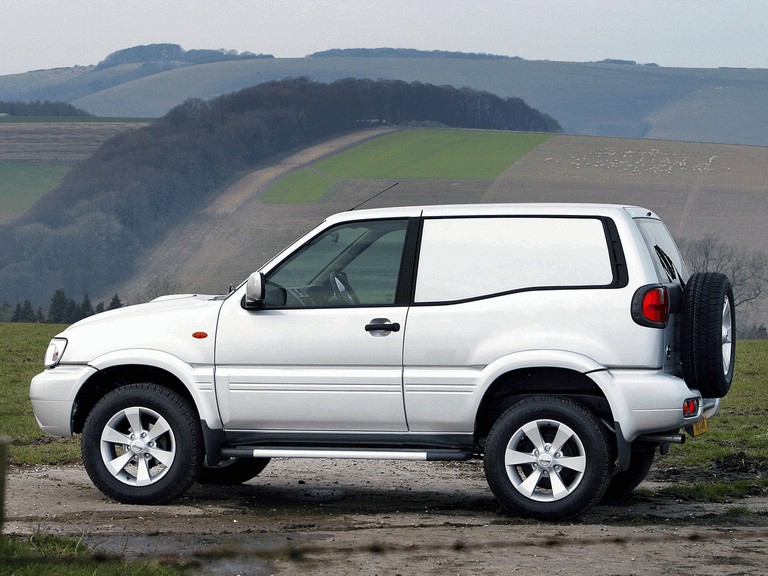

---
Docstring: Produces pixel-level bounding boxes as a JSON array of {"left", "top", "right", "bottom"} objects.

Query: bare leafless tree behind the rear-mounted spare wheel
[{"left": 678, "top": 235, "right": 768, "bottom": 308}]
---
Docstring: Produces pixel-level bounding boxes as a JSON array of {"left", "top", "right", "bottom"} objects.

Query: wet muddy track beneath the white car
[{"left": 4, "top": 460, "right": 768, "bottom": 576}]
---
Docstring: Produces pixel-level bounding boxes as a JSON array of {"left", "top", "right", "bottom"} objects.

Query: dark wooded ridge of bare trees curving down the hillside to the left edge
[{"left": 0, "top": 78, "right": 562, "bottom": 304}]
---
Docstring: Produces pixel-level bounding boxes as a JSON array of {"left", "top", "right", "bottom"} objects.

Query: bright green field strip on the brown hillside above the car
[{"left": 315, "top": 130, "right": 552, "bottom": 180}]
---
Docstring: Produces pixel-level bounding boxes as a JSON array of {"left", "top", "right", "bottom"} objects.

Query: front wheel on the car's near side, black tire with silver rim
[{"left": 81, "top": 383, "right": 204, "bottom": 504}]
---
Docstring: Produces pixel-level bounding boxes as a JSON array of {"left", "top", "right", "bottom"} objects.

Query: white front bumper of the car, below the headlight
[{"left": 29, "top": 364, "right": 97, "bottom": 436}]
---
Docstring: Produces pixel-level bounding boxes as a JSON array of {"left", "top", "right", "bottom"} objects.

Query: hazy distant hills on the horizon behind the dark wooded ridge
[{"left": 0, "top": 47, "right": 768, "bottom": 146}]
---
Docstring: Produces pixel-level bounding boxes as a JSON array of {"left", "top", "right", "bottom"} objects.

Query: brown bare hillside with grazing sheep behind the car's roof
[{"left": 112, "top": 130, "right": 768, "bottom": 326}]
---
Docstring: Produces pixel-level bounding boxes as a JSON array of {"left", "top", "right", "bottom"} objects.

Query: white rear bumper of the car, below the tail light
[{"left": 589, "top": 370, "right": 708, "bottom": 442}]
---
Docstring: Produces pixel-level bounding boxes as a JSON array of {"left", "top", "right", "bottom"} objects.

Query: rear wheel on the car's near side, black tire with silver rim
[{"left": 485, "top": 396, "right": 611, "bottom": 520}]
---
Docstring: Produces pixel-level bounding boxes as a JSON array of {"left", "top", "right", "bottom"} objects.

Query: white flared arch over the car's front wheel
[{"left": 88, "top": 349, "right": 222, "bottom": 429}]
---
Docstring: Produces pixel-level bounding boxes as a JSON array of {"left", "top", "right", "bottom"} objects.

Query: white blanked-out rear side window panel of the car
[{"left": 415, "top": 217, "right": 614, "bottom": 303}]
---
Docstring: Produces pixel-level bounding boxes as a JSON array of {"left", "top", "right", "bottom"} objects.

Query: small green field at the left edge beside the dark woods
[{"left": 0, "top": 160, "right": 73, "bottom": 222}]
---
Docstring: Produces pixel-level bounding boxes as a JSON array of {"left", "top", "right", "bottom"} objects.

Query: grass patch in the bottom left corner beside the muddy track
[{"left": 0, "top": 534, "right": 186, "bottom": 576}]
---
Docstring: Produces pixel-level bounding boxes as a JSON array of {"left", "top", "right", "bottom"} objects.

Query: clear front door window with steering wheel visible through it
[{"left": 264, "top": 220, "right": 408, "bottom": 308}]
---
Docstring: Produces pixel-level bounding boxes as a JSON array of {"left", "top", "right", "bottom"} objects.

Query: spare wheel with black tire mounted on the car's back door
[{"left": 682, "top": 272, "right": 736, "bottom": 398}]
